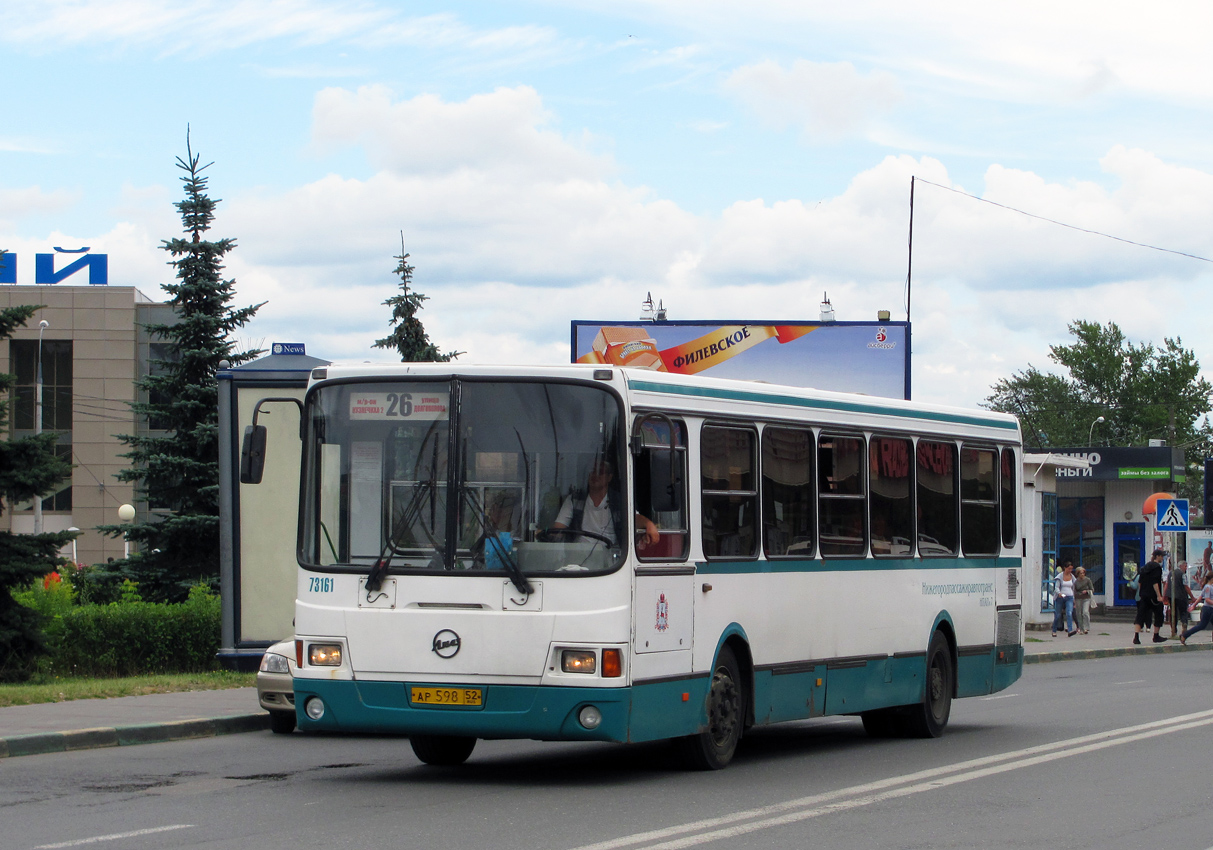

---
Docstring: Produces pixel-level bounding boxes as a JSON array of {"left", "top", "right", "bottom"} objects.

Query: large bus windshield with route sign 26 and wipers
[{"left": 300, "top": 378, "right": 627, "bottom": 575}]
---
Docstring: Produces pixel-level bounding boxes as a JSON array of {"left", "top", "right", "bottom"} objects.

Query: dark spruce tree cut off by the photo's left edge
[{"left": 0, "top": 294, "right": 74, "bottom": 681}]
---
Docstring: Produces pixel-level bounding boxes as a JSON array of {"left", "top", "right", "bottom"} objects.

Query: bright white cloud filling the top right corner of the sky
[{"left": 567, "top": 0, "right": 1213, "bottom": 103}]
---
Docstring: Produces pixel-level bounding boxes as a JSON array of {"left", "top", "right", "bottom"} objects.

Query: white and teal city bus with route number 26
[{"left": 241, "top": 364, "right": 1023, "bottom": 769}]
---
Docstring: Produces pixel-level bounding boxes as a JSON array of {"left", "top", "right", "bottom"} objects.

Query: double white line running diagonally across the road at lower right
[{"left": 575, "top": 711, "right": 1213, "bottom": 850}]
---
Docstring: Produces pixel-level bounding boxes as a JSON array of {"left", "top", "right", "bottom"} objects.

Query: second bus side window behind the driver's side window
[{"left": 762, "top": 427, "right": 816, "bottom": 558}]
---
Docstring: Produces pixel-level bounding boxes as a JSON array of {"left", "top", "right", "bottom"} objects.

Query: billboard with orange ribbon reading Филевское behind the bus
[{"left": 573, "top": 320, "right": 910, "bottom": 399}]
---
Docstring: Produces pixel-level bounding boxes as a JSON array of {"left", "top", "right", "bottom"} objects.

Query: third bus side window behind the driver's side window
[{"left": 818, "top": 434, "right": 867, "bottom": 558}]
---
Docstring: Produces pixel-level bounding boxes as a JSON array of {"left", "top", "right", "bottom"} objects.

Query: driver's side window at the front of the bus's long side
[{"left": 632, "top": 418, "right": 690, "bottom": 561}]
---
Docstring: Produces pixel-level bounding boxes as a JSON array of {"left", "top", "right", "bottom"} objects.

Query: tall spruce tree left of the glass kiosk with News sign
[{"left": 103, "top": 133, "right": 261, "bottom": 601}]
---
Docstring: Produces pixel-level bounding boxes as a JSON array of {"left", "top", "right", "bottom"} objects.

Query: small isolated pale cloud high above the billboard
[{"left": 724, "top": 59, "right": 901, "bottom": 139}]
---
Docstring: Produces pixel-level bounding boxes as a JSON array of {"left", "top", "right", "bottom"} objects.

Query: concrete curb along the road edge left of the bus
[{"left": 0, "top": 712, "right": 269, "bottom": 759}]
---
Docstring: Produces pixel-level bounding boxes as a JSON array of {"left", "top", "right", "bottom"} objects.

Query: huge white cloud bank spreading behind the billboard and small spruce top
[{"left": 231, "top": 87, "right": 1213, "bottom": 405}]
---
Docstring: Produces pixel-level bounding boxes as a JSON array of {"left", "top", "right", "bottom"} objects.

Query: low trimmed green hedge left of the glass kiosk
[{"left": 46, "top": 582, "right": 220, "bottom": 677}]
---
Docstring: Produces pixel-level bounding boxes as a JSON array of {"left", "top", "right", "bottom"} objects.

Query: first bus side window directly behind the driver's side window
[{"left": 699, "top": 426, "right": 758, "bottom": 558}]
